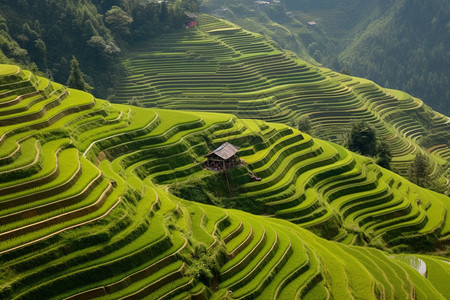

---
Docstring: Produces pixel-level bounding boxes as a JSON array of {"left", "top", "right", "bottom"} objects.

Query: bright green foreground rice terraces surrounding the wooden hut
[{"left": 0, "top": 64, "right": 450, "bottom": 300}]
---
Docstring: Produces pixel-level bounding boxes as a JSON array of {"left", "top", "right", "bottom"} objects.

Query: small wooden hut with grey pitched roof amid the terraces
[{"left": 205, "top": 142, "right": 241, "bottom": 171}]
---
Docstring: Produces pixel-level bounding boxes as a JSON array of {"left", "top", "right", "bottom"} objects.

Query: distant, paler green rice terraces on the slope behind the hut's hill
[{"left": 113, "top": 15, "right": 450, "bottom": 192}]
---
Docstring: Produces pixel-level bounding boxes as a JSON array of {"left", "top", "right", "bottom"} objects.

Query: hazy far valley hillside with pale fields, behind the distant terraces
[{"left": 204, "top": 0, "right": 450, "bottom": 115}]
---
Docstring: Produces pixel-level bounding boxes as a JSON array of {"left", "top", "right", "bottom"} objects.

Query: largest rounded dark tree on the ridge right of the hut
[{"left": 348, "top": 121, "right": 377, "bottom": 157}]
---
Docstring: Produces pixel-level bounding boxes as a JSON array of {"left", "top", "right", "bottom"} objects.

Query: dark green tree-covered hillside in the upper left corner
[{"left": 0, "top": 0, "right": 198, "bottom": 98}]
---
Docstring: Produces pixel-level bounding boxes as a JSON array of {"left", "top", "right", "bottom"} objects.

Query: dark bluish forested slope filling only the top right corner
[{"left": 338, "top": 0, "right": 450, "bottom": 115}]
